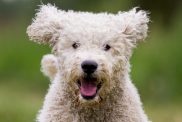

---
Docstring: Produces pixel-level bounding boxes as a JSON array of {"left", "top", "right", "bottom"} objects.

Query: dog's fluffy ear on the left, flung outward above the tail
[{"left": 27, "top": 4, "right": 61, "bottom": 45}]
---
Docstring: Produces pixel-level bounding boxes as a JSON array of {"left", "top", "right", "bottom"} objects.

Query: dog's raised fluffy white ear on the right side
[{"left": 118, "top": 8, "right": 150, "bottom": 46}]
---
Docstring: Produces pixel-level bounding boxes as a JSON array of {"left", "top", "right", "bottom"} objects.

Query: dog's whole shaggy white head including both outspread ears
[{"left": 27, "top": 5, "right": 149, "bottom": 103}]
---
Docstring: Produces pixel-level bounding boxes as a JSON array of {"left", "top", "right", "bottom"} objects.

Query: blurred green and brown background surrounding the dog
[{"left": 0, "top": 0, "right": 182, "bottom": 122}]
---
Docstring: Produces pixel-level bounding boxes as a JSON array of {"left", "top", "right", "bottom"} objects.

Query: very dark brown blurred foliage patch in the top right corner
[{"left": 135, "top": 0, "right": 182, "bottom": 27}]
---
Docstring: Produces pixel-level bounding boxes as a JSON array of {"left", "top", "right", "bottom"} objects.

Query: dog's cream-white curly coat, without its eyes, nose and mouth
[{"left": 27, "top": 4, "right": 149, "bottom": 122}]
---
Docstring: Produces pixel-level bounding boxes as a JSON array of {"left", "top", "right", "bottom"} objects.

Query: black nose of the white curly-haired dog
[{"left": 81, "top": 60, "right": 98, "bottom": 74}]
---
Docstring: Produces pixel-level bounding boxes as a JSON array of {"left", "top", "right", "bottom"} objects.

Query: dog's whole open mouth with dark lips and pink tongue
[{"left": 77, "top": 77, "right": 102, "bottom": 100}]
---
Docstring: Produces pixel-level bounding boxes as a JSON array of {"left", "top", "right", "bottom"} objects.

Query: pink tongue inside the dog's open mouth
[{"left": 80, "top": 80, "right": 97, "bottom": 96}]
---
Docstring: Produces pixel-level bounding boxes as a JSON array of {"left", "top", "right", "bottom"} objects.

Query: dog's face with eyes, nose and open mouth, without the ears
[{"left": 54, "top": 26, "right": 128, "bottom": 103}]
